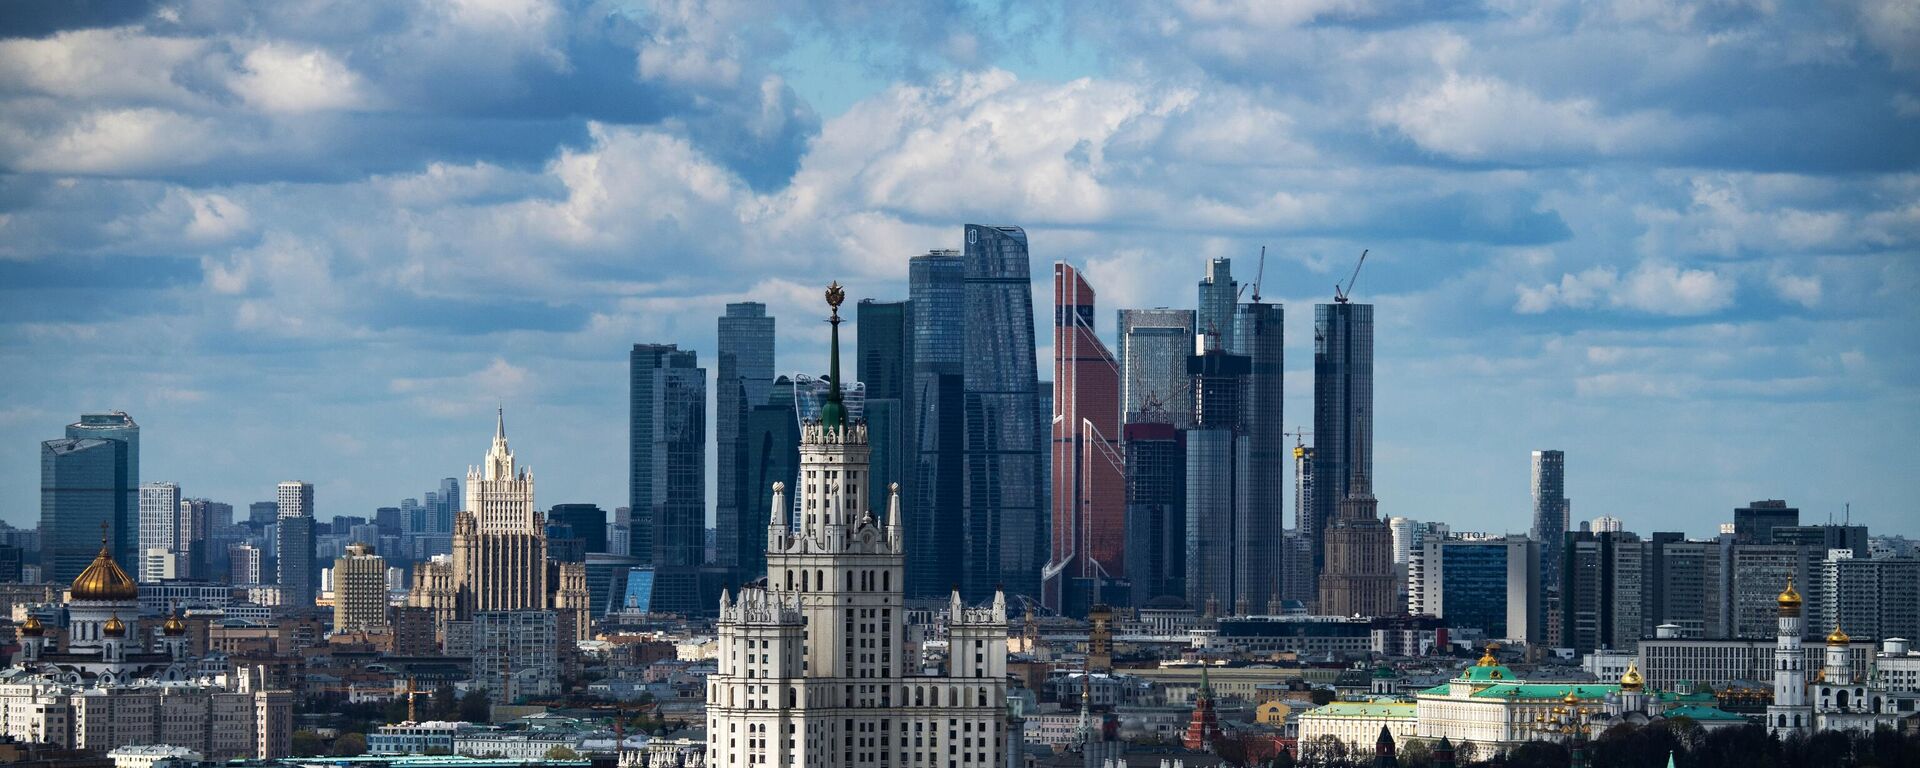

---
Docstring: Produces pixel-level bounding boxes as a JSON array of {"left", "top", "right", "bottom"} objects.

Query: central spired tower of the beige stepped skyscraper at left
[{"left": 453, "top": 411, "right": 549, "bottom": 616}]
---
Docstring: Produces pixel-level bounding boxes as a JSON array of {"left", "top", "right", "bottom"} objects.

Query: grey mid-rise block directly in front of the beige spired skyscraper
[{"left": 468, "top": 611, "right": 561, "bottom": 705}]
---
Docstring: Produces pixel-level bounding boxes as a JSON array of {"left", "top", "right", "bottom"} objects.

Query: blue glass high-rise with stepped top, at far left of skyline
[{"left": 40, "top": 438, "right": 127, "bottom": 584}]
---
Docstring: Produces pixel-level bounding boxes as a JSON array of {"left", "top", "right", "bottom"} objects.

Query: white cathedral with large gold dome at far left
[{"left": 8, "top": 541, "right": 194, "bottom": 687}]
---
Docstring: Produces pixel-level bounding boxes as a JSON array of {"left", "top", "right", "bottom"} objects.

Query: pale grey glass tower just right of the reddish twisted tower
[{"left": 1117, "top": 309, "right": 1194, "bottom": 428}]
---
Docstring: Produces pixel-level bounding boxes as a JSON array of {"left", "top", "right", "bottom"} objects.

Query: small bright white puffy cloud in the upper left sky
[{"left": 227, "top": 42, "right": 371, "bottom": 113}]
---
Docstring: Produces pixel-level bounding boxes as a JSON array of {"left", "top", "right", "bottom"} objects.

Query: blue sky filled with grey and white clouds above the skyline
[{"left": 0, "top": 0, "right": 1920, "bottom": 536}]
